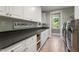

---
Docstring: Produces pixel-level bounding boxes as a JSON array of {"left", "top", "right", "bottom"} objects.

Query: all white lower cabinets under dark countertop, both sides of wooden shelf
[{"left": 1, "top": 30, "right": 49, "bottom": 52}]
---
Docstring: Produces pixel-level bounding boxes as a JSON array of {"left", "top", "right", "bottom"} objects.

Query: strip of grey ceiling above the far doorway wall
[{"left": 41, "top": 6, "right": 73, "bottom": 11}]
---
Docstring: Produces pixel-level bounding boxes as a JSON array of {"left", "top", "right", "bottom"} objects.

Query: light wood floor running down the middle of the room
[{"left": 40, "top": 36, "right": 65, "bottom": 52}]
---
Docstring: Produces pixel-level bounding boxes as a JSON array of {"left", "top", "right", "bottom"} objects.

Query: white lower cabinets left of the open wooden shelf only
[{"left": 1, "top": 35, "right": 36, "bottom": 52}]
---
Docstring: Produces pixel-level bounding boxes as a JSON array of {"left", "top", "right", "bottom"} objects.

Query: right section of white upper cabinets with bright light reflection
[{"left": 24, "top": 6, "right": 41, "bottom": 22}]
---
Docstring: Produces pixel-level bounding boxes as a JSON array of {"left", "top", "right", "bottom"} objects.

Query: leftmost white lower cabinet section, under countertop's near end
[{"left": 1, "top": 40, "right": 25, "bottom": 52}]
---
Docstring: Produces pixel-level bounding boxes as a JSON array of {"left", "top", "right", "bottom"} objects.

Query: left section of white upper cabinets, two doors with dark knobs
[{"left": 0, "top": 6, "right": 24, "bottom": 18}]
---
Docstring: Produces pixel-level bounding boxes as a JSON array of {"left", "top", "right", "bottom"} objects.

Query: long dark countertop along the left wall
[{"left": 0, "top": 27, "right": 48, "bottom": 49}]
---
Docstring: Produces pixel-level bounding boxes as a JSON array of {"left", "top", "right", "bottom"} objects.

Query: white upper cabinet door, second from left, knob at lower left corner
[{"left": 9, "top": 6, "right": 24, "bottom": 18}]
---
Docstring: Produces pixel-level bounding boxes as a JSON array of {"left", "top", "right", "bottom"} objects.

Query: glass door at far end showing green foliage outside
[{"left": 51, "top": 13, "right": 61, "bottom": 34}]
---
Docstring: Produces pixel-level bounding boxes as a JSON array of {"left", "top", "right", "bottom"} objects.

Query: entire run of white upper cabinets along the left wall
[{"left": 0, "top": 6, "right": 41, "bottom": 22}]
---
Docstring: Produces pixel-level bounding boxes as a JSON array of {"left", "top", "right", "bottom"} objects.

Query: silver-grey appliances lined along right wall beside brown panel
[{"left": 63, "top": 20, "right": 74, "bottom": 52}]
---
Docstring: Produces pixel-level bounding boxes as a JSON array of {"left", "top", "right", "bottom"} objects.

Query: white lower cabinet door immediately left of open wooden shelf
[{"left": 26, "top": 35, "right": 36, "bottom": 52}]
